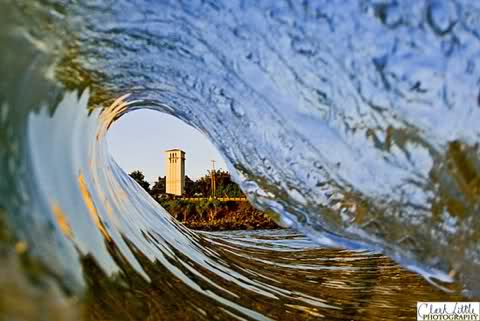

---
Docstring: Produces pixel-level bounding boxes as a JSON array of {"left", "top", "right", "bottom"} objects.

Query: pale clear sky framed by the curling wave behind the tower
[{"left": 107, "top": 110, "right": 227, "bottom": 183}]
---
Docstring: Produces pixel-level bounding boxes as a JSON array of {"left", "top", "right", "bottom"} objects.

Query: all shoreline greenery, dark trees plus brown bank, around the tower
[{"left": 130, "top": 170, "right": 278, "bottom": 231}]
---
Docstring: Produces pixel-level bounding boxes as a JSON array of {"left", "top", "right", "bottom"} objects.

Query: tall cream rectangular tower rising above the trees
[{"left": 165, "top": 148, "right": 185, "bottom": 196}]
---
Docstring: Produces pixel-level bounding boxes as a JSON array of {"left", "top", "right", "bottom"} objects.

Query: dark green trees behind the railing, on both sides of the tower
[{"left": 129, "top": 170, "right": 244, "bottom": 199}]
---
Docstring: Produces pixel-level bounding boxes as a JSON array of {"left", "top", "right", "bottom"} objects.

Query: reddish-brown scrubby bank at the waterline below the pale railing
[{"left": 160, "top": 199, "right": 279, "bottom": 231}]
